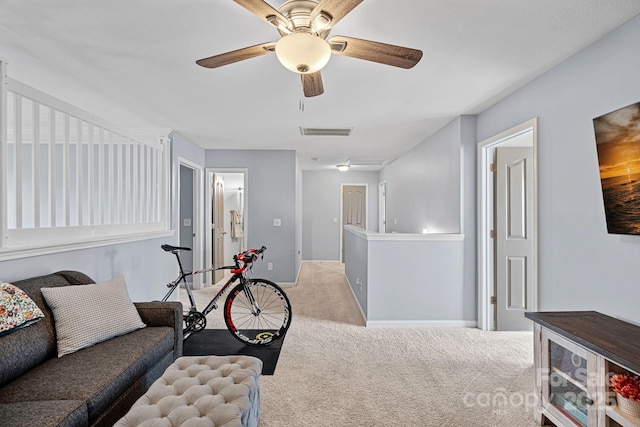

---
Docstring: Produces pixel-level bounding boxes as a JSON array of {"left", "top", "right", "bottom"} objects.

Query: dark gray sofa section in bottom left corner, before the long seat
[{"left": 0, "top": 400, "right": 89, "bottom": 427}]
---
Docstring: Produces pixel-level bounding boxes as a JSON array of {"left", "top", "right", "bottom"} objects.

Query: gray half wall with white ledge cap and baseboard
[{"left": 344, "top": 226, "right": 477, "bottom": 327}]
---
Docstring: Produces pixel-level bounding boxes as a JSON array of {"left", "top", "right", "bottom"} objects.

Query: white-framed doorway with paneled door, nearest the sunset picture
[{"left": 478, "top": 119, "right": 538, "bottom": 330}]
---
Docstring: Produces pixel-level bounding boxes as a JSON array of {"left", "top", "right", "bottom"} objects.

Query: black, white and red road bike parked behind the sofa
[{"left": 161, "top": 244, "right": 292, "bottom": 346}]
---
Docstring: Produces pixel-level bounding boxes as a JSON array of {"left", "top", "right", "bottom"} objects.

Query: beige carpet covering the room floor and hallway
[{"left": 181, "top": 262, "right": 535, "bottom": 427}]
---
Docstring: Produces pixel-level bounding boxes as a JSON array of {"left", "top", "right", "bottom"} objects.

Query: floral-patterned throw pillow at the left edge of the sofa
[{"left": 0, "top": 283, "right": 44, "bottom": 337}]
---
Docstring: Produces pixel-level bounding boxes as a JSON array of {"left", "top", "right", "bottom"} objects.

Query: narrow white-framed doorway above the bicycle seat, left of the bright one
[{"left": 176, "top": 158, "right": 204, "bottom": 289}]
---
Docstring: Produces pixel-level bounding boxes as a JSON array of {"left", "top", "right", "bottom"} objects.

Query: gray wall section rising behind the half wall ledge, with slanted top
[{"left": 380, "top": 117, "right": 462, "bottom": 233}]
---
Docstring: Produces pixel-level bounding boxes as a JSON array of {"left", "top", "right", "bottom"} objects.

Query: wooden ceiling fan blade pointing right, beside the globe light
[{"left": 328, "top": 36, "right": 422, "bottom": 69}]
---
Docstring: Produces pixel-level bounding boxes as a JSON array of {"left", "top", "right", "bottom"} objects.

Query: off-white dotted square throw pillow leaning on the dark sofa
[{"left": 41, "top": 276, "right": 145, "bottom": 357}]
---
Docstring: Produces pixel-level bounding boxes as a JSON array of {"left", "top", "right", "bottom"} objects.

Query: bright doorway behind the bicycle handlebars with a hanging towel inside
[{"left": 205, "top": 168, "right": 248, "bottom": 285}]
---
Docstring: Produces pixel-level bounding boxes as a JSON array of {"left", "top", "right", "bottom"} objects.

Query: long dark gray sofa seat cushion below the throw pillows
[{"left": 0, "top": 327, "right": 174, "bottom": 424}]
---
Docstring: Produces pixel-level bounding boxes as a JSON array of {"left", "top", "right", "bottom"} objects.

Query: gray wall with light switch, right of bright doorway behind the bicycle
[{"left": 205, "top": 150, "right": 297, "bottom": 283}]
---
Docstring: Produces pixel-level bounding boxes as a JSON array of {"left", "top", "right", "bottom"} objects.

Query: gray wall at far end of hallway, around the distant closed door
[{"left": 302, "top": 170, "right": 378, "bottom": 261}]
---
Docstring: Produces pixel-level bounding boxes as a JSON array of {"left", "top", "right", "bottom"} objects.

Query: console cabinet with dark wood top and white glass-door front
[{"left": 525, "top": 311, "right": 640, "bottom": 427}]
